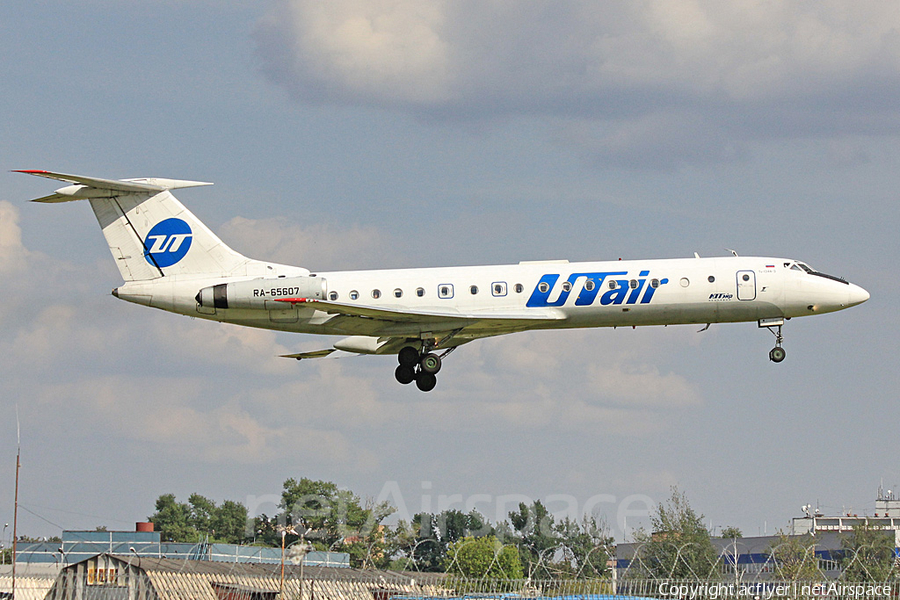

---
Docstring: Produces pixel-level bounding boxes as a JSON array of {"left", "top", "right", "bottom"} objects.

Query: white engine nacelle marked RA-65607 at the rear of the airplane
[{"left": 197, "top": 277, "right": 327, "bottom": 309}]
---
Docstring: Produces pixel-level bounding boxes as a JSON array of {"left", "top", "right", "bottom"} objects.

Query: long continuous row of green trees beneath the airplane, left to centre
[{"left": 150, "top": 478, "right": 613, "bottom": 579}]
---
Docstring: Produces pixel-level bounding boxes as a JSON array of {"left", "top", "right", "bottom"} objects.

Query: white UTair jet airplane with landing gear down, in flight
[{"left": 16, "top": 170, "right": 869, "bottom": 392}]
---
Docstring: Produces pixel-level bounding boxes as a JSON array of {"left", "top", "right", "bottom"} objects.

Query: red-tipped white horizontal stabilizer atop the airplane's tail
[{"left": 14, "top": 170, "right": 212, "bottom": 202}]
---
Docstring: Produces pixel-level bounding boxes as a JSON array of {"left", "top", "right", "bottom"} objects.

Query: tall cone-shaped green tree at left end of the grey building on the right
[{"left": 635, "top": 488, "right": 718, "bottom": 579}]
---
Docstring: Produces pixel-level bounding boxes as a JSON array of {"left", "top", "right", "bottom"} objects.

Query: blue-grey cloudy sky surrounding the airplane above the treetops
[{"left": 0, "top": 0, "right": 900, "bottom": 544}]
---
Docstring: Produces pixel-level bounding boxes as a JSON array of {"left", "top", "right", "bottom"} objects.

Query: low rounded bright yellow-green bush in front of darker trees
[{"left": 445, "top": 535, "right": 522, "bottom": 579}]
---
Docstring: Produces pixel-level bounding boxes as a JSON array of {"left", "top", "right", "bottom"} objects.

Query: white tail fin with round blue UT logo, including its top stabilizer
[{"left": 17, "top": 171, "right": 257, "bottom": 281}]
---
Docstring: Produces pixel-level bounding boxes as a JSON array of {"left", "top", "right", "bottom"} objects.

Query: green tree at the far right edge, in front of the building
[{"left": 840, "top": 521, "right": 898, "bottom": 582}]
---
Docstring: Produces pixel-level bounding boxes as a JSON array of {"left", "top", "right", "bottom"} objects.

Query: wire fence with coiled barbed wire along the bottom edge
[{"left": 7, "top": 539, "right": 900, "bottom": 600}]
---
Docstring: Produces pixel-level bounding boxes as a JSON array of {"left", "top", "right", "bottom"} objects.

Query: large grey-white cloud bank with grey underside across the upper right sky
[{"left": 256, "top": 0, "right": 900, "bottom": 168}]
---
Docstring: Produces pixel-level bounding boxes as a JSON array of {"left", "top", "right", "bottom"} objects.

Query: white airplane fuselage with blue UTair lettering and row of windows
[{"left": 116, "top": 257, "right": 869, "bottom": 339}]
